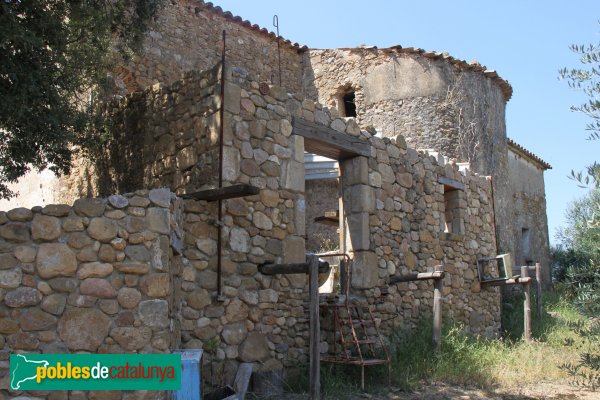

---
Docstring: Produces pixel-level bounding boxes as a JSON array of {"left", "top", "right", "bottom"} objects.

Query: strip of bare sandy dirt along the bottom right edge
[{"left": 278, "top": 383, "right": 600, "bottom": 400}]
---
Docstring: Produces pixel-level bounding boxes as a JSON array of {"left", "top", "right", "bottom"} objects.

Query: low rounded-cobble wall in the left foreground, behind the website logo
[{"left": 0, "top": 189, "right": 181, "bottom": 399}]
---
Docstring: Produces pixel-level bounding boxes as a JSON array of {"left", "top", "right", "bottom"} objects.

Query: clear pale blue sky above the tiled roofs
[{"left": 215, "top": 0, "right": 600, "bottom": 242}]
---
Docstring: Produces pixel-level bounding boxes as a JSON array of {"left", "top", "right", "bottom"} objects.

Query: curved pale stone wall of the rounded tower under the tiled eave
[{"left": 304, "top": 48, "right": 514, "bottom": 272}]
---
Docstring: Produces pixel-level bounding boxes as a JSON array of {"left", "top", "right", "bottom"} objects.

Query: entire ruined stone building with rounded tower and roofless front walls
[{"left": 0, "top": 0, "right": 550, "bottom": 398}]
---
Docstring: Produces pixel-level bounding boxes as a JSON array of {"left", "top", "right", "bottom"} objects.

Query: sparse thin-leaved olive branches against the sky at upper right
[{"left": 559, "top": 28, "right": 600, "bottom": 187}]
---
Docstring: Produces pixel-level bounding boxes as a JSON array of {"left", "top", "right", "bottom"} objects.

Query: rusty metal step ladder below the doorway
[{"left": 320, "top": 297, "right": 391, "bottom": 390}]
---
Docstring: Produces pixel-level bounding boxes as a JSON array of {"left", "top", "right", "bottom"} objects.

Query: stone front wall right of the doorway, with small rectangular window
[{"left": 342, "top": 136, "right": 500, "bottom": 337}]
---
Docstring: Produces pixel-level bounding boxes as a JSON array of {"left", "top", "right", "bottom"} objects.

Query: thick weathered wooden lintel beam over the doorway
[{"left": 292, "top": 117, "right": 371, "bottom": 160}]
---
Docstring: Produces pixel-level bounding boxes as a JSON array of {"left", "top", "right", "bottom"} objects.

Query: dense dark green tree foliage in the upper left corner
[{"left": 0, "top": 0, "right": 162, "bottom": 198}]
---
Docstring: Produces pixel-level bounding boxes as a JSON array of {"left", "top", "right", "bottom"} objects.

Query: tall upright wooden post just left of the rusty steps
[{"left": 308, "top": 256, "right": 321, "bottom": 400}]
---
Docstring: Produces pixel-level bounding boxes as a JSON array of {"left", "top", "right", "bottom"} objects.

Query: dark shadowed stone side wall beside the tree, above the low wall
[{"left": 60, "top": 65, "right": 223, "bottom": 204}]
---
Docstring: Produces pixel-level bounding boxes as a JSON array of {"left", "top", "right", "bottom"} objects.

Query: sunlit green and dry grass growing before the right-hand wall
[{"left": 288, "top": 293, "right": 598, "bottom": 399}]
